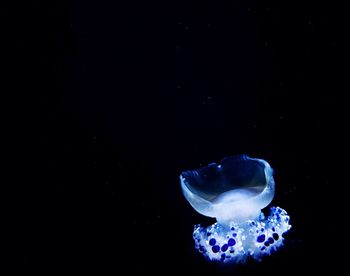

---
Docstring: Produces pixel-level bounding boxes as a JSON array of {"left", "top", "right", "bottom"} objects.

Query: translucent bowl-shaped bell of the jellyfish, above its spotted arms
[{"left": 180, "top": 155, "right": 275, "bottom": 226}]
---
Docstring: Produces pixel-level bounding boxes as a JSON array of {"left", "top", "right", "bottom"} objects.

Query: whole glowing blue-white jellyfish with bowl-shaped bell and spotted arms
[{"left": 180, "top": 155, "right": 291, "bottom": 263}]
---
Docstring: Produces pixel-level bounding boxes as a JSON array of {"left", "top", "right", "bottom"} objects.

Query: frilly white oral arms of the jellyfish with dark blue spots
[{"left": 193, "top": 207, "right": 291, "bottom": 263}]
